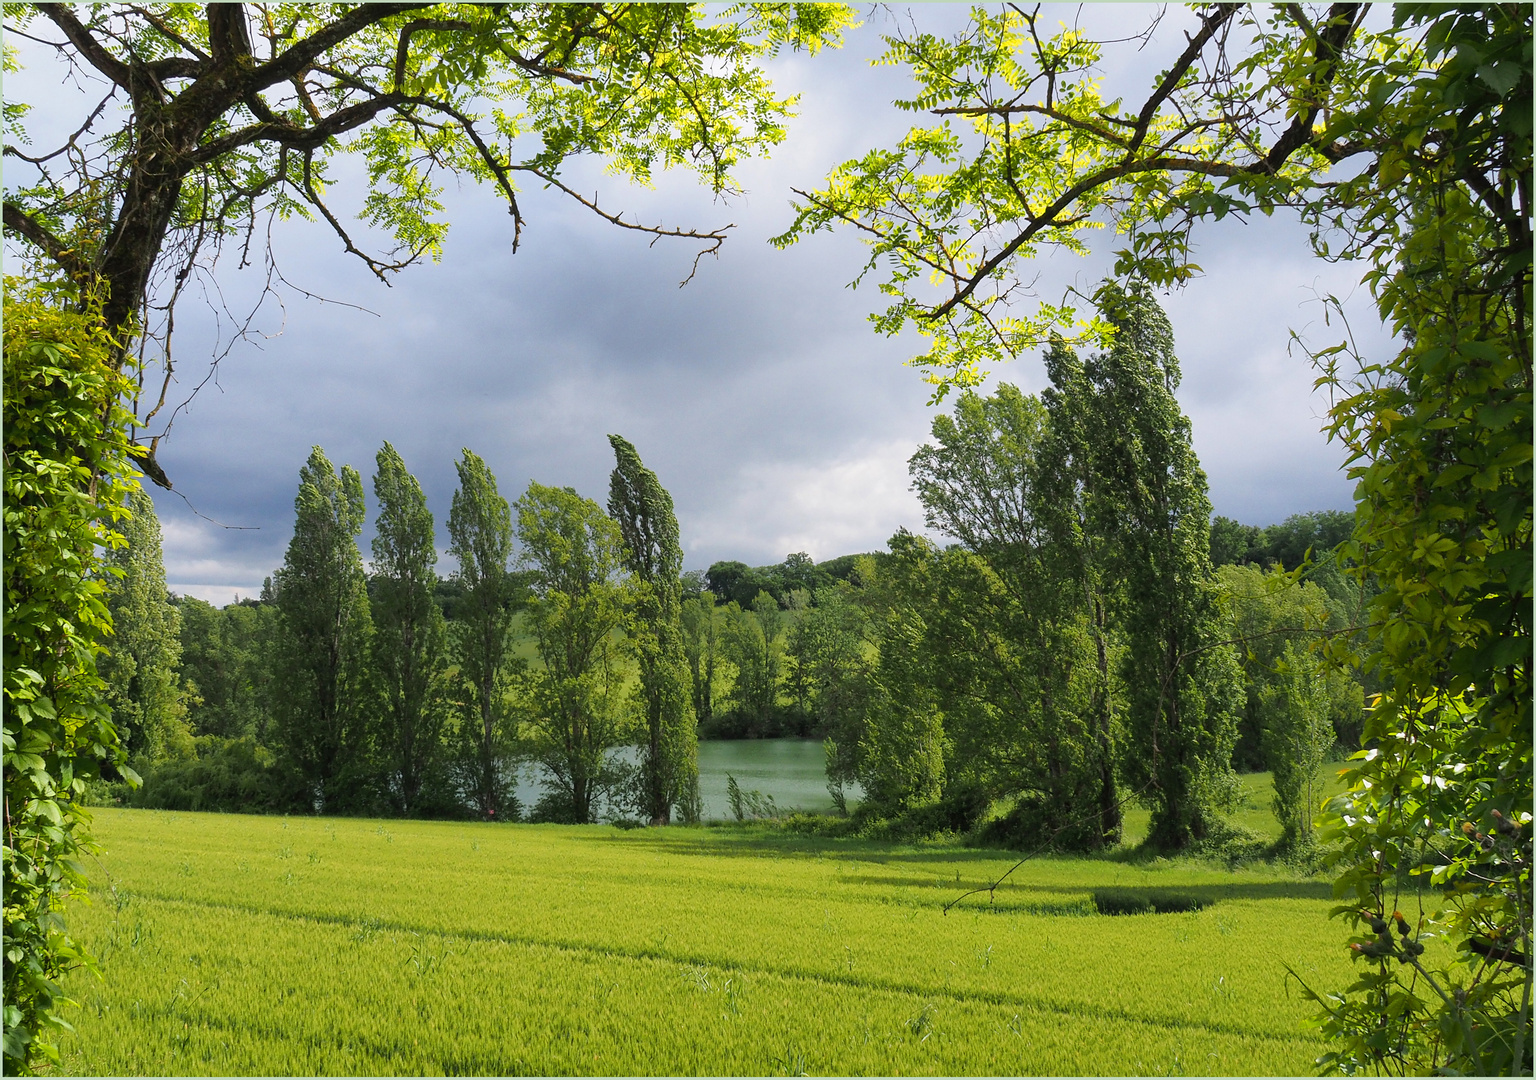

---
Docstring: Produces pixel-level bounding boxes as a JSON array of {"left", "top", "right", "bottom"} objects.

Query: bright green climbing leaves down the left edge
[{"left": 3, "top": 278, "right": 137, "bottom": 1074}]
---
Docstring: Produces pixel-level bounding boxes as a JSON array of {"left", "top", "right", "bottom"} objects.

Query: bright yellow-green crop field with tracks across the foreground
[{"left": 61, "top": 810, "right": 1349, "bottom": 1075}]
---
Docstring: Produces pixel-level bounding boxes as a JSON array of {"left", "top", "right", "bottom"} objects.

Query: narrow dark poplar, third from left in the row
[{"left": 372, "top": 442, "right": 447, "bottom": 814}]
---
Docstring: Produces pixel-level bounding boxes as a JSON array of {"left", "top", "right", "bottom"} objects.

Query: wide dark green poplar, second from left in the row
[{"left": 270, "top": 447, "right": 373, "bottom": 810}]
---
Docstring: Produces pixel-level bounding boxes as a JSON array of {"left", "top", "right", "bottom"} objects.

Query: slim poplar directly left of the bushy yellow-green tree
[{"left": 449, "top": 447, "right": 519, "bottom": 820}]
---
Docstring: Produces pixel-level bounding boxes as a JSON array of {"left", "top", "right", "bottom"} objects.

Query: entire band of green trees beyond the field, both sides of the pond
[{"left": 106, "top": 292, "right": 1369, "bottom": 850}]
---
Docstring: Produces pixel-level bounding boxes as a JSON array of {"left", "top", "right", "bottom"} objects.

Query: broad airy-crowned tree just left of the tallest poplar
[{"left": 909, "top": 384, "right": 1120, "bottom": 848}]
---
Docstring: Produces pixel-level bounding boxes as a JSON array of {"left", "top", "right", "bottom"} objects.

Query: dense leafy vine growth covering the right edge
[{"left": 1290, "top": 5, "right": 1533, "bottom": 1074}]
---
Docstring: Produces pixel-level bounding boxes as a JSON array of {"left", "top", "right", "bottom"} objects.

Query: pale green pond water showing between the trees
[{"left": 518, "top": 739, "right": 860, "bottom": 819}]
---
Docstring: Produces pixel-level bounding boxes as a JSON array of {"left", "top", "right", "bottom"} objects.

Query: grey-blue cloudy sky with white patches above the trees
[{"left": 6, "top": 5, "right": 1384, "bottom": 602}]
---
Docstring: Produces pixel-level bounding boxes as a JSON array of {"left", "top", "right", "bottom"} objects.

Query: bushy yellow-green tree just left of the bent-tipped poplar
[{"left": 516, "top": 482, "right": 634, "bottom": 823}]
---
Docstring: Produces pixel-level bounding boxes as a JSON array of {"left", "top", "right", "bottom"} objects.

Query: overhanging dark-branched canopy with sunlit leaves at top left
[{"left": 5, "top": 3, "right": 851, "bottom": 482}]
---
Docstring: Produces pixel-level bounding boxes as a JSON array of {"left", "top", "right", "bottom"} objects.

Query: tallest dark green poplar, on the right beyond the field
[{"left": 1087, "top": 284, "right": 1243, "bottom": 848}]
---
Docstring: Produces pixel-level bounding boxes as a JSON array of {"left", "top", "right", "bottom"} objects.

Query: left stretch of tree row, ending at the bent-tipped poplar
[{"left": 104, "top": 436, "right": 699, "bottom": 823}]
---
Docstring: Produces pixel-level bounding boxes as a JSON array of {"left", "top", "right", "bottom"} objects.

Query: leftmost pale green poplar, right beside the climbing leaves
[{"left": 97, "top": 487, "right": 192, "bottom": 765}]
